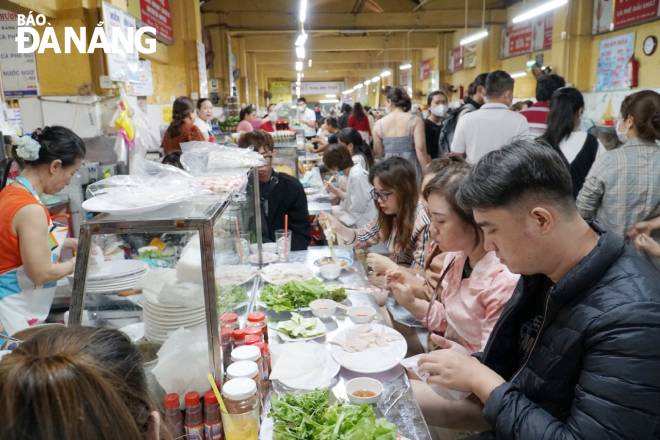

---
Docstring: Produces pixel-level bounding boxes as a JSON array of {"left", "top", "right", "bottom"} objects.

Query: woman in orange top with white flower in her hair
[{"left": 0, "top": 126, "right": 85, "bottom": 340}]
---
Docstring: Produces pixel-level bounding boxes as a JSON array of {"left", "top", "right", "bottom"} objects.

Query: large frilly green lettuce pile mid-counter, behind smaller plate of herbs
[{"left": 261, "top": 278, "right": 346, "bottom": 312}]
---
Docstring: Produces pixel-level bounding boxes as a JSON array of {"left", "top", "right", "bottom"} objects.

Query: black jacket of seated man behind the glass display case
[{"left": 259, "top": 171, "right": 312, "bottom": 251}]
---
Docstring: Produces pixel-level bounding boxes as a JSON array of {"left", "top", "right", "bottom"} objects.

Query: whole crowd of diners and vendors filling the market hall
[{"left": 0, "top": 67, "right": 660, "bottom": 439}]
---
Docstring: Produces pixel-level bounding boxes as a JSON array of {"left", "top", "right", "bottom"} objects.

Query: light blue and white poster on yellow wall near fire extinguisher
[{"left": 596, "top": 32, "right": 635, "bottom": 92}]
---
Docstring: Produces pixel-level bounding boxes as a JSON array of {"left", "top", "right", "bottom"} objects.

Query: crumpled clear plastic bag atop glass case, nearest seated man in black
[{"left": 180, "top": 141, "right": 266, "bottom": 176}]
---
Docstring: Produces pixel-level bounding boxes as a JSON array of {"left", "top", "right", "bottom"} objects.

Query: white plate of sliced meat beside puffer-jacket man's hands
[{"left": 330, "top": 324, "right": 408, "bottom": 374}]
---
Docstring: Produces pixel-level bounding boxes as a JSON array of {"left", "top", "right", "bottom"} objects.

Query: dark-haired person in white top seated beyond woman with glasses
[{"left": 323, "top": 144, "right": 378, "bottom": 228}]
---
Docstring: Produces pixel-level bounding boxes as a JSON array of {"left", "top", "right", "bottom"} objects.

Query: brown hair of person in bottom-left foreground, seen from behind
[{"left": 0, "top": 326, "right": 170, "bottom": 440}]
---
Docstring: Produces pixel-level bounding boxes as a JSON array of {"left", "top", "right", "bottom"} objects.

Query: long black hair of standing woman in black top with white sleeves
[{"left": 541, "top": 87, "right": 584, "bottom": 151}]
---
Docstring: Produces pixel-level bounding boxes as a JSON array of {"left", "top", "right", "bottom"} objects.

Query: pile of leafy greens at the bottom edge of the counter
[{"left": 269, "top": 390, "right": 397, "bottom": 440}]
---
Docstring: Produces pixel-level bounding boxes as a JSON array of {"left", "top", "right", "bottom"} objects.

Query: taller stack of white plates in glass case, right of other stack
[{"left": 142, "top": 296, "right": 206, "bottom": 342}]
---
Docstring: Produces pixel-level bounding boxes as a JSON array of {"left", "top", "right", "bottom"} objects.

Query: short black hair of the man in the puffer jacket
[{"left": 456, "top": 139, "right": 576, "bottom": 213}]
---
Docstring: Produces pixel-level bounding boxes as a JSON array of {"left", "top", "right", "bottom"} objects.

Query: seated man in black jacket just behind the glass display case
[{"left": 238, "top": 130, "right": 311, "bottom": 251}]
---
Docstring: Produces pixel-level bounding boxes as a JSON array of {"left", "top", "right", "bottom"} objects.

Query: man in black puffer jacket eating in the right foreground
[{"left": 420, "top": 141, "right": 660, "bottom": 440}]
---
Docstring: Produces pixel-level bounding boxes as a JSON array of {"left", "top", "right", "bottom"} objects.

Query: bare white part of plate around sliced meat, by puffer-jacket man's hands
[{"left": 330, "top": 324, "right": 408, "bottom": 374}]
